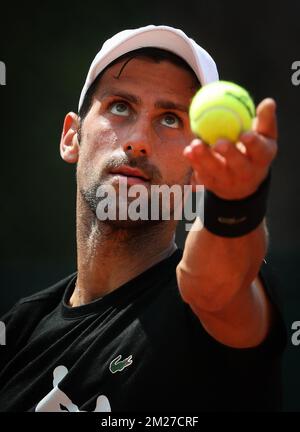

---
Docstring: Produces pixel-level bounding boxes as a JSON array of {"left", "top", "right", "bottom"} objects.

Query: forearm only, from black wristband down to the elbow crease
[{"left": 178, "top": 219, "right": 267, "bottom": 312}]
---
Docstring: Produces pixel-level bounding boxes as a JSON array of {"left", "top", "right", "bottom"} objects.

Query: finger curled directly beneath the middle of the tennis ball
[{"left": 214, "top": 140, "right": 253, "bottom": 180}]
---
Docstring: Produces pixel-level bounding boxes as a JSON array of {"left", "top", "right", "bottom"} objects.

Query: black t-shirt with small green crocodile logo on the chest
[{"left": 0, "top": 251, "right": 285, "bottom": 412}]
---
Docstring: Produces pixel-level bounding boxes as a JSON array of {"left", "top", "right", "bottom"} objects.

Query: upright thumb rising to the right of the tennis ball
[{"left": 253, "top": 98, "right": 277, "bottom": 140}]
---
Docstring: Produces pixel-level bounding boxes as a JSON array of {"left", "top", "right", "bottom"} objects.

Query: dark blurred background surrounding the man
[{"left": 0, "top": 0, "right": 300, "bottom": 411}]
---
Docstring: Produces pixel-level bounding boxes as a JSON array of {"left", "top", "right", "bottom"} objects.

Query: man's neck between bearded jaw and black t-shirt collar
[{"left": 70, "top": 196, "right": 177, "bottom": 306}]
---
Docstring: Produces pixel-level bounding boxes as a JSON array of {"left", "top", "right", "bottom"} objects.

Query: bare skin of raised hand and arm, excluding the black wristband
[{"left": 177, "top": 99, "right": 277, "bottom": 348}]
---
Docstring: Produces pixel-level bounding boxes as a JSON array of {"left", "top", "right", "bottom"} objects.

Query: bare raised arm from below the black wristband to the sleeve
[{"left": 177, "top": 221, "right": 269, "bottom": 347}]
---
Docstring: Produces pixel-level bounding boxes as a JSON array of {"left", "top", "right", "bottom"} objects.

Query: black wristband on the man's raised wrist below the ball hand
[{"left": 204, "top": 172, "right": 271, "bottom": 237}]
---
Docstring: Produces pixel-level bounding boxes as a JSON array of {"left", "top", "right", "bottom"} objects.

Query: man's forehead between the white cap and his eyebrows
[{"left": 95, "top": 57, "right": 199, "bottom": 103}]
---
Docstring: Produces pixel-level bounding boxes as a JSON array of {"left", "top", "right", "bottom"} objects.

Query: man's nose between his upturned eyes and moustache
[{"left": 123, "top": 119, "right": 152, "bottom": 157}]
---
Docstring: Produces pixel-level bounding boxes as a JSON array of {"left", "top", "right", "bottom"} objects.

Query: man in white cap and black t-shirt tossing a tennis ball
[{"left": 0, "top": 26, "right": 284, "bottom": 412}]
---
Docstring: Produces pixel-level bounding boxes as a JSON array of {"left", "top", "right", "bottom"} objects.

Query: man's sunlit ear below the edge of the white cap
[{"left": 60, "top": 112, "right": 79, "bottom": 163}]
